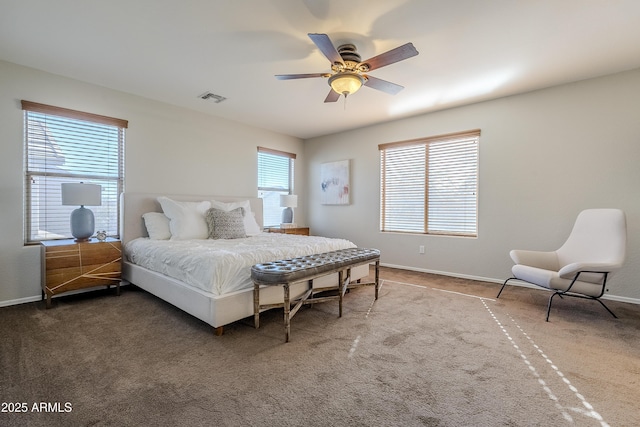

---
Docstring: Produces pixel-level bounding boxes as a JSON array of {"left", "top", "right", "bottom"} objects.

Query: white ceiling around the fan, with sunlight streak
[{"left": 0, "top": 0, "right": 640, "bottom": 138}]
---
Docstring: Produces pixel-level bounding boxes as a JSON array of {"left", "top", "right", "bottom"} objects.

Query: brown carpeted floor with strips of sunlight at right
[{"left": 0, "top": 268, "right": 640, "bottom": 426}]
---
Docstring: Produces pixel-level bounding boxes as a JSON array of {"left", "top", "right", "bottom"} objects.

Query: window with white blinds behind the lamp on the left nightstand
[{"left": 22, "top": 101, "right": 127, "bottom": 243}]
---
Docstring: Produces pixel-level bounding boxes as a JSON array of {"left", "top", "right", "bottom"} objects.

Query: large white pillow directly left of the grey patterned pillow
[{"left": 158, "top": 197, "right": 211, "bottom": 240}]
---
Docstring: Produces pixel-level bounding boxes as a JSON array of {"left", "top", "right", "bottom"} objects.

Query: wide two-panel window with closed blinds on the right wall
[{"left": 378, "top": 130, "right": 480, "bottom": 236}]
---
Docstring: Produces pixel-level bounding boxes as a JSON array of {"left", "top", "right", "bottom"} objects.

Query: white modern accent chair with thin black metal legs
[{"left": 496, "top": 209, "right": 627, "bottom": 322}]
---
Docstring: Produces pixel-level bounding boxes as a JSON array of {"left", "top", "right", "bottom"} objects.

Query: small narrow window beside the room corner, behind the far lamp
[{"left": 258, "top": 147, "right": 296, "bottom": 227}]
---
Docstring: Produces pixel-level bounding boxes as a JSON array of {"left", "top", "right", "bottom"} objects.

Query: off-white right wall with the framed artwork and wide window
[{"left": 305, "top": 70, "right": 640, "bottom": 302}]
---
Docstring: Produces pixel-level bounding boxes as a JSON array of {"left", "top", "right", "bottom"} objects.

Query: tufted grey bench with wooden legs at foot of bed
[{"left": 251, "top": 248, "right": 380, "bottom": 342}]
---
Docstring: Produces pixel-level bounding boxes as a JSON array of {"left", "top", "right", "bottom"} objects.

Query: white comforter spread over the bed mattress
[{"left": 124, "top": 233, "right": 356, "bottom": 295}]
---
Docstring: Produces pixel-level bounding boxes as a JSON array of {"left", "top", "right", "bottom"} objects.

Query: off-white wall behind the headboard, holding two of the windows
[{"left": 0, "top": 61, "right": 306, "bottom": 305}]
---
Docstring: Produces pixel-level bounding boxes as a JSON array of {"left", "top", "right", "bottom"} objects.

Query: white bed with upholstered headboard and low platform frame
[{"left": 120, "top": 193, "right": 369, "bottom": 335}]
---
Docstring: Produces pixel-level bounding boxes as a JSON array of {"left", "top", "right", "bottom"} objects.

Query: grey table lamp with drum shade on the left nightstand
[{"left": 61, "top": 182, "right": 102, "bottom": 242}]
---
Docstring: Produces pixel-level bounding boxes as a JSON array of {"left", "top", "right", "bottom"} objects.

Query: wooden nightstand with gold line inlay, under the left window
[{"left": 40, "top": 238, "right": 122, "bottom": 308}]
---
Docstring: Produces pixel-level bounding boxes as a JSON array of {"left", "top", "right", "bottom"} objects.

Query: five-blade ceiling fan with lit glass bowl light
[{"left": 276, "top": 33, "right": 418, "bottom": 102}]
